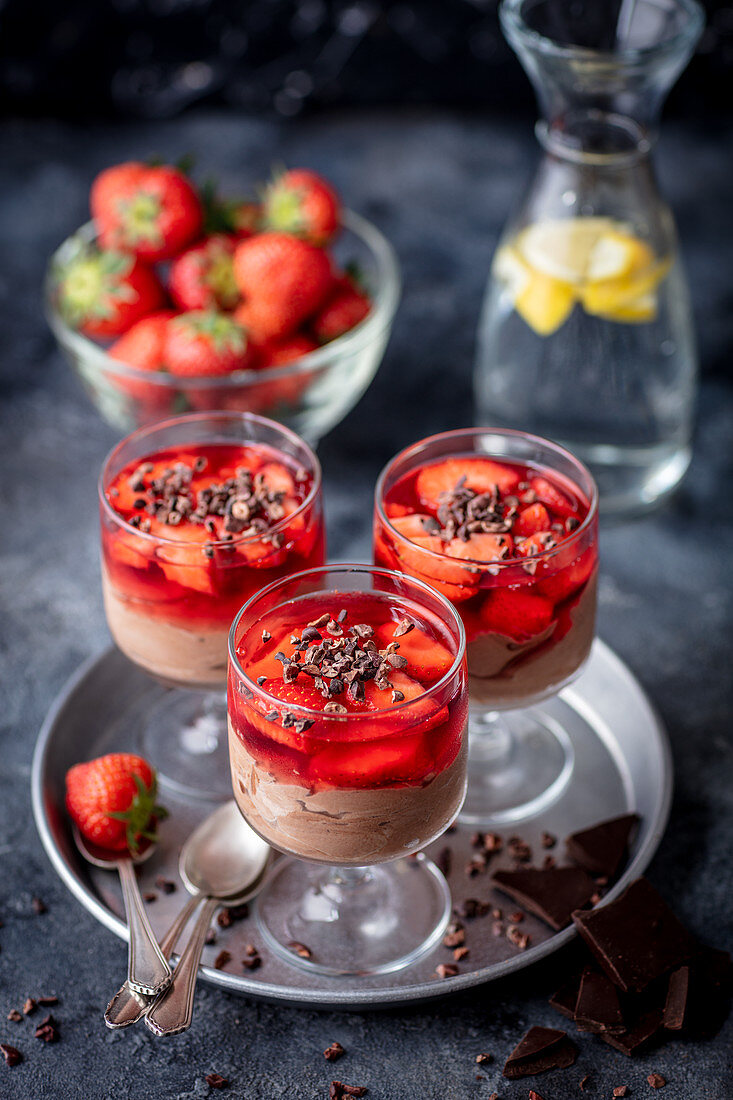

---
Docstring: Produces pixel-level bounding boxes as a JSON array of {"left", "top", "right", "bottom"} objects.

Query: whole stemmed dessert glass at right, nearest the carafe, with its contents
[{"left": 374, "top": 428, "right": 598, "bottom": 826}]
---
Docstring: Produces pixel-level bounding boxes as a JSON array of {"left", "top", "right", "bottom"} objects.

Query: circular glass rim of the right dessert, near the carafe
[{"left": 374, "top": 427, "right": 599, "bottom": 575}]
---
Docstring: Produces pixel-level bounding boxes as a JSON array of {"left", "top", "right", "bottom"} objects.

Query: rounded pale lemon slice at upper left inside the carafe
[{"left": 517, "top": 217, "right": 614, "bottom": 284}]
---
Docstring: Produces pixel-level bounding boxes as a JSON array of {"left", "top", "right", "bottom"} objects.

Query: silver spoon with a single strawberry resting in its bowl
[{"left": 74, "top": 828, "right": 172, "bottom": 997}]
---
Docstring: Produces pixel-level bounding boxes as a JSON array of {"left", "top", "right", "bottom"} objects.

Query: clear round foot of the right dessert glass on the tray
[{"left": 459, "top": 710, "right": 575, "bottom": 827}]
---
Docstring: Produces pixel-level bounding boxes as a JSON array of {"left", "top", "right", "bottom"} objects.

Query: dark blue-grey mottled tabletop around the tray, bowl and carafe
[{"left": 0, "top": 112, "right": 733, "bottom": 1100}]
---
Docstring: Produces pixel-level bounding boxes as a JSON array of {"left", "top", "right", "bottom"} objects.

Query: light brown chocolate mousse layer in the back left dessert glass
[{"left": 102, "top": 569, "right": 228, "bottom": 689}]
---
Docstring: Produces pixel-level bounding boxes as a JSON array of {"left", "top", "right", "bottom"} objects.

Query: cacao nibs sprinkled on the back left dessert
[{"left": 122, "top": 457, "right": 299, "bottom": 548}]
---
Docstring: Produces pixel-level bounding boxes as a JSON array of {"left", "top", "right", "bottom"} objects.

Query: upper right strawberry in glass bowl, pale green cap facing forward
[{"left": 262, "top": 168, "right": 341, "bottom": 245}]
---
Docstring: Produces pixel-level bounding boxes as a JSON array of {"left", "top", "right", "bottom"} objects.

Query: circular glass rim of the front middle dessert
[{"left": 228, "top": 561, "right": 466, "bottom": 723}]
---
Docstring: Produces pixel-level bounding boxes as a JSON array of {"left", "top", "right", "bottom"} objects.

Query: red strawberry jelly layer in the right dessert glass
[{"left": 374, "top": 453, "right": 597, "bottom": 664}]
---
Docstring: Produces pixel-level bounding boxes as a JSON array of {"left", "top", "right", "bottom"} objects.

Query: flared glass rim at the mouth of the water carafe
[{"left": 499, "top": 0, "right": 705, "bottom": 64}]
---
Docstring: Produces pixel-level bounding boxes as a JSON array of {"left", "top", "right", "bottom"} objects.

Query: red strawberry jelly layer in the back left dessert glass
[{"left": 101, "top": 443, "right": 325, "bottom": 630}]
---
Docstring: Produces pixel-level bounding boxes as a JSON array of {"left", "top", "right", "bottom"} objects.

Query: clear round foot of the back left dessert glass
[{"left": 140, "top": 689, "right": 231, "bottom": 801}]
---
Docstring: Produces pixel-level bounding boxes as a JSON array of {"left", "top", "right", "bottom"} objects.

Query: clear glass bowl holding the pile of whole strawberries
[{"left": 44, "top": 210, "right": 401, "bottom": 443}]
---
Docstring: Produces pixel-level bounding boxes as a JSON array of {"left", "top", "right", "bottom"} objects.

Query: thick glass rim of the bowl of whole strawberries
[{"left": 44, "top": 209, "right": 402, "bottom": 391}]
